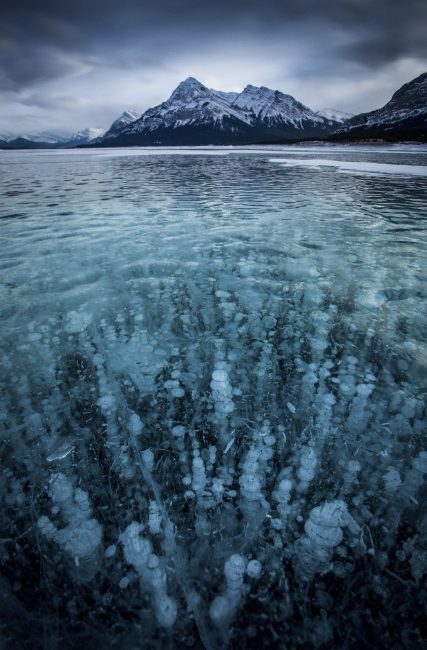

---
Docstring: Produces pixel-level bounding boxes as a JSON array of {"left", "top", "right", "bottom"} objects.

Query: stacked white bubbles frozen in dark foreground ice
[{"left": 0, "top": 260, "right": 427, "bottom": 649}]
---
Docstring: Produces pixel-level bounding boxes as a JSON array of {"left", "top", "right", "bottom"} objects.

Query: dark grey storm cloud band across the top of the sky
[{"left": 0, "top": 0, "right": 427, "bottom": 87}]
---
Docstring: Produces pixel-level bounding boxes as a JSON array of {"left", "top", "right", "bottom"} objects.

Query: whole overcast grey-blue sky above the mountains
[{"left": 0, "top": 0, "right": 427, "bottom": 133}]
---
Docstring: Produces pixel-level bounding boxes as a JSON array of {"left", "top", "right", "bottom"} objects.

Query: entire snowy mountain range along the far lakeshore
[{"left": 0, "top": 73, "right": 427, "bottom": 149}]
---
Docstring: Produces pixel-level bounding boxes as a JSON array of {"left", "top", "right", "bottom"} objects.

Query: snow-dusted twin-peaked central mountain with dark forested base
[{"left": 96, "top": 77, "right": 339, "bottom": 146}]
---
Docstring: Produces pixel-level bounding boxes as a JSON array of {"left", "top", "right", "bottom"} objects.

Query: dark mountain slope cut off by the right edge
[{"left": 337, "top": 72, "right": 427, "bottom": 141}]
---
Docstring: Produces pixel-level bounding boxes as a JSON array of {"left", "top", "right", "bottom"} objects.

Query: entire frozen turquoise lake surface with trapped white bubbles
[{"left": 0, "top": 145, "right": 427, "bottom": 650}]
